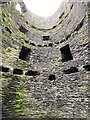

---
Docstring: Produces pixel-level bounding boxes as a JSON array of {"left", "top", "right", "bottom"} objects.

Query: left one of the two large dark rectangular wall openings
[{"left": 19, "top": 46, "right": 31, "bottom": 60}]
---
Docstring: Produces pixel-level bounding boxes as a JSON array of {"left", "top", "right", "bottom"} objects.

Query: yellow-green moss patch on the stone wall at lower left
[{"left": 3, "top": 76, "right": 26, "bottom": 117}]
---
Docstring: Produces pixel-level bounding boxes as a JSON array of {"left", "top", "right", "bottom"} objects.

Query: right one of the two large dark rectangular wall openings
[{"left": 60, "top": 45, "right": 73, "bottom": 62}]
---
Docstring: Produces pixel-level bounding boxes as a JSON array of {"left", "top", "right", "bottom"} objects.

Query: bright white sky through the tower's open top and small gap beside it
[{"left": 16, "top": 0, "right": 63, "bottom": 17}]
